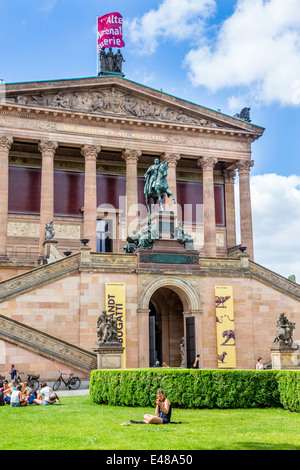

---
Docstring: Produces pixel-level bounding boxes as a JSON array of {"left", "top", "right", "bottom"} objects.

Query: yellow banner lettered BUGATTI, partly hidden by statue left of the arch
[{"left": 105, "top": 282, "right": 126, "bottom": 368}]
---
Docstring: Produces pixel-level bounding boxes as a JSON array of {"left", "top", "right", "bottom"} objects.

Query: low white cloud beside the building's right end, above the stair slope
[{"left": 236, "top": 173, "right": 300, "bottom": 283}]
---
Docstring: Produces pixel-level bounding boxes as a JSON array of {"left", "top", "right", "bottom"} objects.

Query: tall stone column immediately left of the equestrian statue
[{"left": 122, "top": 150, "right": 142, "bottom": 235}]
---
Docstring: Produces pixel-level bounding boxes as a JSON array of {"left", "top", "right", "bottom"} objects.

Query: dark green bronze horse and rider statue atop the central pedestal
[{"left": 144, "top": 159, "right": 176, "bottom": 215}]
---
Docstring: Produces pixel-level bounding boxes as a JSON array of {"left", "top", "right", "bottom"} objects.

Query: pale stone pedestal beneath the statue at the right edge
[{"left": 270, "top": 343, "right": 300, "bottom": 370}]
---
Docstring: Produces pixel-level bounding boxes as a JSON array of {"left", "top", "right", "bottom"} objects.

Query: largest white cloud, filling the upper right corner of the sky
[{"left": 185, "top": 0, "right": 300, "bottom": 105}]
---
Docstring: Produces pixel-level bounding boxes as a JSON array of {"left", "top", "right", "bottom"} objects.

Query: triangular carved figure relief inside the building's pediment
[{"left": 9, "top": 86, "right": 219, "bottom": 130}]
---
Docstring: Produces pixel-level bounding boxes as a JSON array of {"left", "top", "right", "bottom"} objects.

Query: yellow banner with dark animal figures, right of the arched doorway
[{"left": 215, "top": 286, "right": 236, "bottom": 369}]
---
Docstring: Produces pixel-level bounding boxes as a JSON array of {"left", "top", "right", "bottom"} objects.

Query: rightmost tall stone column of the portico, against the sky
[{"left": 236, "top": 160, "right": 254, "bottom": 260}]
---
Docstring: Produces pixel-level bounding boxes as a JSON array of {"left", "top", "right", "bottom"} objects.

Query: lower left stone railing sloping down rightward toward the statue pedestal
[{"left": 0, "top": 315, "right": 97, "bottom": 375}]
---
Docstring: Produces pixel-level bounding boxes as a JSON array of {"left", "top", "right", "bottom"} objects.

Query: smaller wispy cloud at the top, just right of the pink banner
[{"left": 125, "top": 0, "right": 216, "bottom": 53}]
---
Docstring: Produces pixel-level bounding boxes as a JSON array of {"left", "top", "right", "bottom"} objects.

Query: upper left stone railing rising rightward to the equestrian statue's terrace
[{"left": 0, "top": 253, "right": 80, "bottom": 302}]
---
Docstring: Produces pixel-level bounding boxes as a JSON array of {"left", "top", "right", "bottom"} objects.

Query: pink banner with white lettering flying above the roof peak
[{"left": 97, "top": 12, "right": 125, "bottom": 52}]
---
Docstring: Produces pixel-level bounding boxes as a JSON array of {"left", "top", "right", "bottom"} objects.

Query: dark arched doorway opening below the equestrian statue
[{"left": 149, "top": 287, "right": 184, "bottom": 367}]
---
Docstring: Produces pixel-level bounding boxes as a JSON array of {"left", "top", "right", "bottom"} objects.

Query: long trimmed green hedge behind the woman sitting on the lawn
[{"left": 90, "top": 368, "right": 300, "bottom": 411}]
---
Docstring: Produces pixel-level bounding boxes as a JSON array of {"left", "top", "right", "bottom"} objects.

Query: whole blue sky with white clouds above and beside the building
[{"left": 0, "top": 0, "right": 300, "bottom": 282}]
